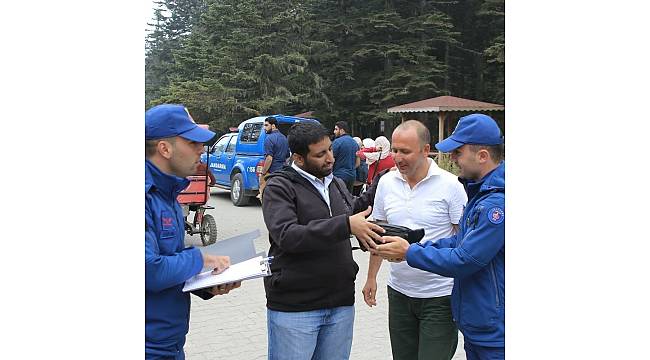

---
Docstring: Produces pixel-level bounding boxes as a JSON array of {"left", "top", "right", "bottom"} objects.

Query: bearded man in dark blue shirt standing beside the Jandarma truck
[{"left": 257, "top": 116, "right": 289, "bottom": 200}]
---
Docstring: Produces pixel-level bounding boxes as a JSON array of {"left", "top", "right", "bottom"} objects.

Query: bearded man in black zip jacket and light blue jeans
[{"left": 262, "top": 123, "right": 383, "bottom": 360}]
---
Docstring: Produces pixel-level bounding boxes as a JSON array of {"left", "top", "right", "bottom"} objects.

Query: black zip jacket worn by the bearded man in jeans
[{"left": 262, "top": 166, "right": 378, "bottom": 311}]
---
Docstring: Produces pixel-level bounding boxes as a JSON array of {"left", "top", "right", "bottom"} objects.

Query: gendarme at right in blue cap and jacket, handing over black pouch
[{"left": 371, "top": 114, "right": 506, "bottom": 360}]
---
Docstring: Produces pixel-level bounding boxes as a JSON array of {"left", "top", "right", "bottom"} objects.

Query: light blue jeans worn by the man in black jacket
[{"left": 266, "top": 306, "right": 354, "bottom": 360}]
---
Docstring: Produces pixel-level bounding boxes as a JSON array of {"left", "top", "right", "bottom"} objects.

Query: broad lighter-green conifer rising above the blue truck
[{"left": 155, "top": 0, "right": 328, "bottom": 128}]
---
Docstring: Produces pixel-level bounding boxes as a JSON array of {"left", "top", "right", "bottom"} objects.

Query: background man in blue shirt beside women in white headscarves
[{"left": 332, "top": 121, "right": 359, "bottom": 193}]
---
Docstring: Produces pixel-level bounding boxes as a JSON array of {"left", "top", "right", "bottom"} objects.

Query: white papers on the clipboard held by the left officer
[{"left": 183, "top": 256, "right": 272, "bottom": 292}]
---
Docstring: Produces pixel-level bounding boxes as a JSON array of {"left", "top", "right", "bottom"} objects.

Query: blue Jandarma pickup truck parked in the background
[{"left": 201, "top": 115, "right": 318, "bottom": 206}]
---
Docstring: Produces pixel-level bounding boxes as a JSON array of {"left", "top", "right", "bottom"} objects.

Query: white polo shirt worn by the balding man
[{"left": 372, "top": 159, "right": 467, "bottom": 298}]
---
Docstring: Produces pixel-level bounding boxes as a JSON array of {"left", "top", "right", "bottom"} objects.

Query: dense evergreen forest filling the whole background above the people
[{"left": 145, "top": 0, "right": 505, "bottom": 136}]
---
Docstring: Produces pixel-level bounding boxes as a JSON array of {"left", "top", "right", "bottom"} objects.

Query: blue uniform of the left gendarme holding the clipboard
[{"left": 144, "top": 160, "right": 203, "bottom": 358}]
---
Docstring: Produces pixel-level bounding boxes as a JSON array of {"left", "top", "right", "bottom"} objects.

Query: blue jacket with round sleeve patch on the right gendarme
[{"left": 406, "top": 162, "right": 505, "bottom": 348}]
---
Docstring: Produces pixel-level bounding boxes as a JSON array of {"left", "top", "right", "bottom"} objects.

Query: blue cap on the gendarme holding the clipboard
[{"left": 144, "top": 104, "right": 215, "bottom": 143}]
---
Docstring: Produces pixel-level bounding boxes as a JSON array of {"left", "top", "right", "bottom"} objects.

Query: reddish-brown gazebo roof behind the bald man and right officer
[{"left": 388, "top": 95, "right": 505, "bottom": 113}]
